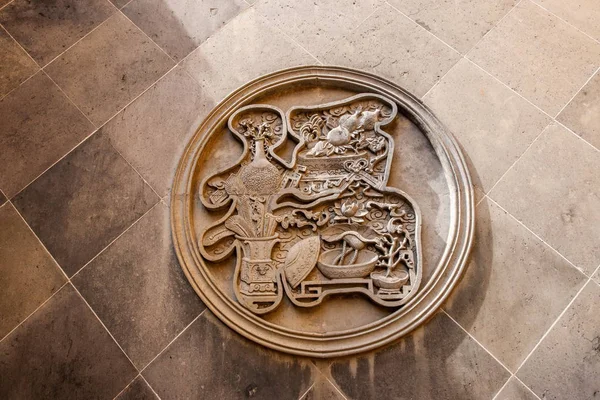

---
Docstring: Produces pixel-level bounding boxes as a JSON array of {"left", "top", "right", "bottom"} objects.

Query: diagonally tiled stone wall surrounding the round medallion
[{"left": 0, "top": 0, "right": 600, "bottom": 400}]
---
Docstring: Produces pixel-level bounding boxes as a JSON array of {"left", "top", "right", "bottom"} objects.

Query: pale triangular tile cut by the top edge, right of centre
[{"left": 389, "top": 0, "right": 518, "bottom": 54}]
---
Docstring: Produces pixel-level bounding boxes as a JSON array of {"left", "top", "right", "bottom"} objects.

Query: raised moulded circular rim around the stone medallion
[{"left": 171, "top": 66, "right": 475, "bottom": 358}]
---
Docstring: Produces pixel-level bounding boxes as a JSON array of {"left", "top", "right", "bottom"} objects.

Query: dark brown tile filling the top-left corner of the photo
[{"left": 0, "top": 0, "right": 116, "bottom": 66}]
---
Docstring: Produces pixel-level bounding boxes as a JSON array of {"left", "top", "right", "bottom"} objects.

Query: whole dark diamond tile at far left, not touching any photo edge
[{"left": 14, "top": 134, "right": 159, "bottom": 276}]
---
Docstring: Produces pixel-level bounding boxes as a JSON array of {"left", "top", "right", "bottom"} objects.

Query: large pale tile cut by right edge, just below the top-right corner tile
[{"left": 468, "top": 0, "right": 600, "bottom": 116}]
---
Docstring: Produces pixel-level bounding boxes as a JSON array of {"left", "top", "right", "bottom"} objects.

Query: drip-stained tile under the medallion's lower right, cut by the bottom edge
[{"left": 331, "top": 313, "right": 510, "bottom": 400}]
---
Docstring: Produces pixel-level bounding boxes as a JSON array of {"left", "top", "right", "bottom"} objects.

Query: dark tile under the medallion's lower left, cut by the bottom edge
[{"left": 143, "top": 310, "right": 315, "bottom": 400}]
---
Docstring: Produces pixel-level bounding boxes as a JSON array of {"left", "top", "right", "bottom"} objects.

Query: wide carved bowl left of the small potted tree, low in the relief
[{"left": 317, "top": 249, "right": 379, "bottom": 279}]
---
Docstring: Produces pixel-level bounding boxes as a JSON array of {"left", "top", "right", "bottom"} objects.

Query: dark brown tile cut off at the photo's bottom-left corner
[{"left": 0, "top": 285, "right": 136, "bottom": 399}]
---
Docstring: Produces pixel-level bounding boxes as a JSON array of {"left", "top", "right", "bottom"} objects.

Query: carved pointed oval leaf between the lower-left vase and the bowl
[{"left": 283, "top": 236, "right": 321, "bottom": 288}]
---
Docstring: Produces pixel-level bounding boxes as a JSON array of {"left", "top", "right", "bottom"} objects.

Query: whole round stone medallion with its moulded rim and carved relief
[{"left": 171, "top": 66, "right": 474, "bottom": 357}]
